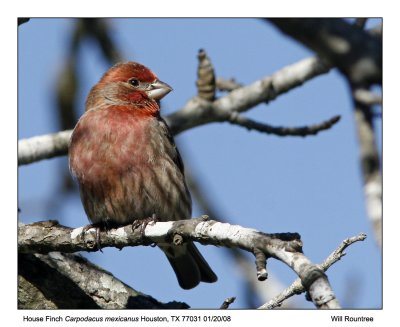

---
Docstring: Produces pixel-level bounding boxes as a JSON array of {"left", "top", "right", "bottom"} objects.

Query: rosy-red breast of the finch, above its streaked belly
[{"left": 70, "top": 107, "right": 157, "bottom": 182}]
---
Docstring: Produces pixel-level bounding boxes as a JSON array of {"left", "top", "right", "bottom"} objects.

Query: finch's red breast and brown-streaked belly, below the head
[{"left": 69, "top": 109, "right": 191, "bottom": 224}]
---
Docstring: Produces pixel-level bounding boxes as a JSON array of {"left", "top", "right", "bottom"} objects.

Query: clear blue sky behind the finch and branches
[{"left": 18, "top": 19, "right": 382, "bottom": 308}]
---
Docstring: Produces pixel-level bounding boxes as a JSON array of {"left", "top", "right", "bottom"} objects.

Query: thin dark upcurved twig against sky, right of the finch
[{"left": 229, "top": 113, "right": 340, "bottom": 137}]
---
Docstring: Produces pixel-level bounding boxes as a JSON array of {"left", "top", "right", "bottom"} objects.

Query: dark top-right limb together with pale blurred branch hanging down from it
[{"left": 270, "top": 18, "right": 382, "bottom": 245}]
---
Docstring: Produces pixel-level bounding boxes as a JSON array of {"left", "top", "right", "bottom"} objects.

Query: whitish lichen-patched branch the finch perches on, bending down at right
[{"left": 18, "top": 216, "right": 339, "bottom": 308}]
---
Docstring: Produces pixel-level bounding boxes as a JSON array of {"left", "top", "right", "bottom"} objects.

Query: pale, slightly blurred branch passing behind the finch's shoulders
[{"left": 18, "top": 58, "right": 330, "bottom": 165}]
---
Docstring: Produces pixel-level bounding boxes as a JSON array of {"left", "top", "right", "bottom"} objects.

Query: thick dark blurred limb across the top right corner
[{"left": 270, "top": 18, "right": 382, "bottom": 84}]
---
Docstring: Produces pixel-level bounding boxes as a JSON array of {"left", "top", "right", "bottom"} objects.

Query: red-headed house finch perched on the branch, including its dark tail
[{"left": 69, "top": 62, "right": 217, "bottom": 289}]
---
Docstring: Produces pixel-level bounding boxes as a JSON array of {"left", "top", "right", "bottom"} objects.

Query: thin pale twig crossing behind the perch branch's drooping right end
[{"left": 258, "top": 233, "right": 367, "bottom": 309}]
